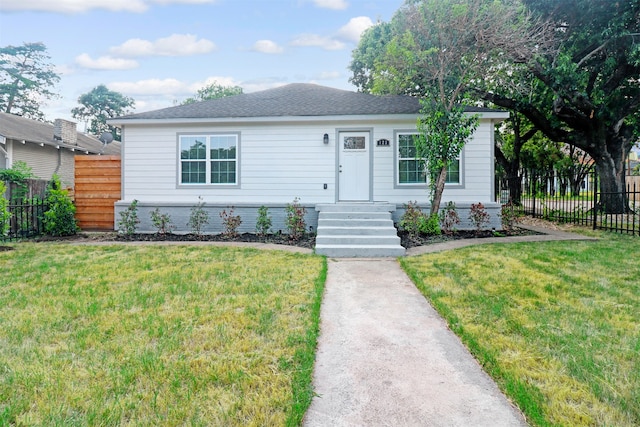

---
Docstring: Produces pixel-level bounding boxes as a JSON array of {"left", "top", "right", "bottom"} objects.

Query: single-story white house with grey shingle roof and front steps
[{"left": 109, "top": 84, "right": 508, "bottom": 256}]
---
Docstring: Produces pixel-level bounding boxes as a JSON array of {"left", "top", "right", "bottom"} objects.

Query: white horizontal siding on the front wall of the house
[{"left": 122, "top": 115, "right": 500, "bottom": 206}]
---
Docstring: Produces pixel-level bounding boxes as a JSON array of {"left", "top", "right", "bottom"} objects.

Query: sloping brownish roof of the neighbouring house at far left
[{"left": 0, "top": 112, "right": 121, "bottom": 155}]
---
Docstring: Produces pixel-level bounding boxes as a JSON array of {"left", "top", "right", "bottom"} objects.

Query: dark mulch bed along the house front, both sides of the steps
[{"left": 27, "top": 227, "right": 540, "bottom": 250}]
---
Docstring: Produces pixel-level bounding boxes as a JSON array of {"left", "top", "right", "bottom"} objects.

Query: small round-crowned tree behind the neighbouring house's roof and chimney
[{"left": 71, "top": 85, "right": 135, "bottom": 141}]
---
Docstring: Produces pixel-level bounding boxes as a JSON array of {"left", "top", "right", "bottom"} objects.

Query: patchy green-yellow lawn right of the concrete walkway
[{"left": 401, "top": 233, "right": 640, "bottom": 426}]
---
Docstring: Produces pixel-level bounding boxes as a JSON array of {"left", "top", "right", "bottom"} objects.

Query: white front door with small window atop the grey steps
[{"left": 338, "top": 132, "right": 370, "bottom": 201}]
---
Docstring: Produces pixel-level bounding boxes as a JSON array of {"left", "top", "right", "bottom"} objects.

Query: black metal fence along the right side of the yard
[{"left": 497, "top": 171, "right": 640, "bottom": 236}]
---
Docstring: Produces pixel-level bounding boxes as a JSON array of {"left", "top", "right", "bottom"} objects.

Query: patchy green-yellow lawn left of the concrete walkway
[{"left": 0, "top": 243, "right": 326, "bottom": 426}]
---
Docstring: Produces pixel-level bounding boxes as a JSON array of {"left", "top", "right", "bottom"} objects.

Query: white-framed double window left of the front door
[{"left": 179, "top": 133, "right": 239, "bottom": 185}]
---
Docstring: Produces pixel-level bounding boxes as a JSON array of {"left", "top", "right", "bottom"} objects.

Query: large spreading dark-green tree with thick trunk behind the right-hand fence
[{"left": 352, "top": 0, "right": 640, "bottom": 213}]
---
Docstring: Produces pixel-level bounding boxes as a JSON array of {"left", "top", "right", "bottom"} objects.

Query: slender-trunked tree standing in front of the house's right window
[{"left": 350, "top": 0, "right": 529, "bottom": 213}]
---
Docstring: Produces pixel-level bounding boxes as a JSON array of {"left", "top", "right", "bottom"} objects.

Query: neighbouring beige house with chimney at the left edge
[{"left": 0, "top": 113, "right": 120, "bottom": 187}]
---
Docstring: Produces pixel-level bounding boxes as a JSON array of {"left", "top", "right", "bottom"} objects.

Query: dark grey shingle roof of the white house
[{"left": 109, "top": 83, "right": 508, "bottom": 124}]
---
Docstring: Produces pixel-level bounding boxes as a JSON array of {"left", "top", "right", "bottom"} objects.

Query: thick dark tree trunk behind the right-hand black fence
[{"left": 595, "top": 154, "right": 629, "bottom": 214}]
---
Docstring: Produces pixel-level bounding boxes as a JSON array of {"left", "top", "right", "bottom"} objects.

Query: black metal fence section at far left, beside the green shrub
[{"left": 0, "top": 198, "right": 47, "bottom": 241}]
